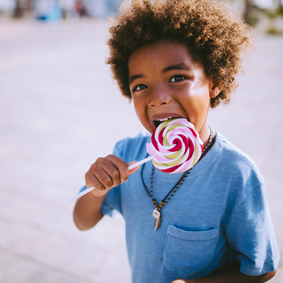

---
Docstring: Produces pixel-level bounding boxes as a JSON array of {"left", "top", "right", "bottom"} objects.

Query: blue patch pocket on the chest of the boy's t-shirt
[{"left": 163, "top": 225, "right": 219, "bottom": 277}]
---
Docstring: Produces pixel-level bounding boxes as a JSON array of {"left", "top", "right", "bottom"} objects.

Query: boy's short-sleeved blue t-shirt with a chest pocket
[{"left": 102, "top": 133, "right": 280, "bottom": 283}]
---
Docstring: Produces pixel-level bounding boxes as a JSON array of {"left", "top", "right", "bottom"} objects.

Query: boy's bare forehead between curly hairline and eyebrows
[{"left": 128, "top": 40, "right": 202, "bottom": 74}]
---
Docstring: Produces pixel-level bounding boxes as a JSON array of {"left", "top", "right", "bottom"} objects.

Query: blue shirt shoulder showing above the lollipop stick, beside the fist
[{"left": 114, "top": 131, "right": 151, "bottom": 163}]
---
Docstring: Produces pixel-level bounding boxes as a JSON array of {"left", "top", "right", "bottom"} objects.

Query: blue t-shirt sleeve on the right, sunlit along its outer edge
[{"left": 226, "top": 185, "right": 280, "bottom": 276}]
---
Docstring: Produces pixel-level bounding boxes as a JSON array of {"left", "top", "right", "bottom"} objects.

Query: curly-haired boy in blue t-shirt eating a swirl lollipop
[{"left": 74, "top": 0, "right": 279, "bottom": 283}]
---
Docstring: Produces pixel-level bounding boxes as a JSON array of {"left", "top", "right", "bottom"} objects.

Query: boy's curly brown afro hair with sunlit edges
[{"left": 107, "top": 0, "right": 251, "bottom": 108}]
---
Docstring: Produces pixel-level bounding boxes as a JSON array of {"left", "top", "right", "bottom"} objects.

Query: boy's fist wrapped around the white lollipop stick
[{"left": 85, "top": 155, "right": 139, "bottom": 197}]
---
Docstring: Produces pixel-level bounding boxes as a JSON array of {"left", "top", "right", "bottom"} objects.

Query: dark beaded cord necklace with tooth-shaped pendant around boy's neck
[{"left": 141, "top": 129, "right": 215, "bottom": 231}]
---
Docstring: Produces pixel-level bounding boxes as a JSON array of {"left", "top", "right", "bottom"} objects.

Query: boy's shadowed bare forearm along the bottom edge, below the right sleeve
[{"left": 172, "top": 262, "right": 276, "bottom": 283}]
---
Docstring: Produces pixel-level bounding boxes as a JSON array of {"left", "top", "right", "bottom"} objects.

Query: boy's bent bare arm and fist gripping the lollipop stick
[{"left": 73, "top": 155, "right": 139, "bottom": 230}]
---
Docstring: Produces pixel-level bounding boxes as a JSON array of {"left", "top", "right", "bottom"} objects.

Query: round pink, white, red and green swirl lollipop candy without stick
[{"left": 146, "top": 118, "right": 203, "bottom": 173}]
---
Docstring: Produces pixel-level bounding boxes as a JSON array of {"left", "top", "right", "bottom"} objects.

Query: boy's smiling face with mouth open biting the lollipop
[{"left": 128, "top": 40, "right": 218, "bottom": 142}]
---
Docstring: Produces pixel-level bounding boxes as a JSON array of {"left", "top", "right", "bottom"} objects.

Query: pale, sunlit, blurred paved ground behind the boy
[{"left": 0, "top": 18, "right": 283, "bottom": 283}]
